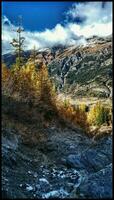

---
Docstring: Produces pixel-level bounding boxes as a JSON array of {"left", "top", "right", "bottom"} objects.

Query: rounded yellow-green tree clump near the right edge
[{"left": 88, "top": 102, "right": 110, "bottom": 125}]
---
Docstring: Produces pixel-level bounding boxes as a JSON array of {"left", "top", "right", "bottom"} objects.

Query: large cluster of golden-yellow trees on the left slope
[{"left": 2, "top": 61, "right": 55, "bottom": 108}]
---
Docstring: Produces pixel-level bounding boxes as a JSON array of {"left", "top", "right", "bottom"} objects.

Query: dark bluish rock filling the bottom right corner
[{"left": 76, "top": 164, "right": 112, "bottom": 199}]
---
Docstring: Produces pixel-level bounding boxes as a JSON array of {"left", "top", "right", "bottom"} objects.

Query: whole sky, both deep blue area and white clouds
[{"left": 2, "top": 1, "right": 112, "bottom": 54}]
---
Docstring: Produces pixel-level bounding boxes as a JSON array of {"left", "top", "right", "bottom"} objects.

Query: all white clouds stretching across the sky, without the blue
[{"left": 2, "top": 2, "right": 112, "bottom": 54}]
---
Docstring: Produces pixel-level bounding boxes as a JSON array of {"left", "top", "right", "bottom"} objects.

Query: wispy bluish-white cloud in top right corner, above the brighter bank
[{"left": 66, "top": 2, "right": 112, "bottom": 25}]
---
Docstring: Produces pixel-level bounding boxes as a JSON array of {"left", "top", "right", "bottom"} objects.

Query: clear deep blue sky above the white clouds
[{"left": 2, "top": 2, "right": 73, "bottom": 31}]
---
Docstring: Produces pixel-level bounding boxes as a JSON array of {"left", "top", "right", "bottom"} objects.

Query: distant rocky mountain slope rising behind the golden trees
[{"left": 3, "top": 36, "right": 112, "bottom": 98}]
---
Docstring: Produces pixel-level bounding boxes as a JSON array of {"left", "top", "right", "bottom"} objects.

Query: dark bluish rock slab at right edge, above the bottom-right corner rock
[{"left": 66, "top": 137, "right": 112, "bottom": 173}]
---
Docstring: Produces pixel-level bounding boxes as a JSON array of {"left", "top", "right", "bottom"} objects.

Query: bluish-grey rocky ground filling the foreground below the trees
[{"left": 2, "top": 119, "right": 112, "bottom": 199}]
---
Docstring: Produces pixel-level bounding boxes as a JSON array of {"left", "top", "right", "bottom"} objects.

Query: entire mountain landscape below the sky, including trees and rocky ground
[{"left": 2, "top": 34, "right": 112, "bottom": 199}]
